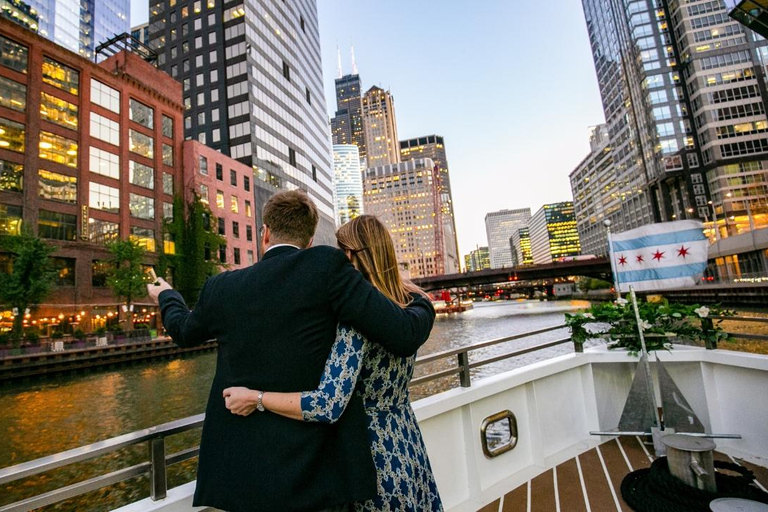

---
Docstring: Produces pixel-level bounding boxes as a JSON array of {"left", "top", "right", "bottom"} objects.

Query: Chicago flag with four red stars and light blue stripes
[{"left": 610, "top": 220, "right": 709, "bottom": 292}]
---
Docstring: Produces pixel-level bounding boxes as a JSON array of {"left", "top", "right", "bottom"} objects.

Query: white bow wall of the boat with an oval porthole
[{"left": 114, "top": 346, "right": 768, "bottom": 512}]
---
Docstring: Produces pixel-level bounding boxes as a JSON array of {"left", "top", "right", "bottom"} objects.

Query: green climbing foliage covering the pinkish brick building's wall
[{"left": 164, "top": 195, "right": 227, "bottom": 305}]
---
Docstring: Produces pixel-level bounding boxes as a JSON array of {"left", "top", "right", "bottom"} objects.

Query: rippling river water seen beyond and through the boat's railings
[{"left": 0, "top": 301, "right": 588, "bottom": 510}]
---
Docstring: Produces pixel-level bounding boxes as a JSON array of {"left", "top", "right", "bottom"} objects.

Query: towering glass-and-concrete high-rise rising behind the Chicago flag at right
[{"left": 578, "top": 0, "right": 768, "bottom": 236}]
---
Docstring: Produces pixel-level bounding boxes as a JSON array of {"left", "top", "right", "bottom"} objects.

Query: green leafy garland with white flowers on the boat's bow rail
[{"left": 565, "top": 298, "right": 733, "bottom": 355}]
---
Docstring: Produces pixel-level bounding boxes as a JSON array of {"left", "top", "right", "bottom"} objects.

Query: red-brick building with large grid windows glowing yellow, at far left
[{"left": 0, "top": 19, "right": 183, "bottom": 332}]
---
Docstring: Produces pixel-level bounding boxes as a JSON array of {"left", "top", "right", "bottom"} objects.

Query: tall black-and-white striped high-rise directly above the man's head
[{"left": 149, "top": 0, "right": 335, "bottom": 248}]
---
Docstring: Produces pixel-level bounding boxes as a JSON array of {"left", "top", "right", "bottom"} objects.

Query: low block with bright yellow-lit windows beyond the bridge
[{"left": 528, "top": 201, "right": 581, "bottom": 265}]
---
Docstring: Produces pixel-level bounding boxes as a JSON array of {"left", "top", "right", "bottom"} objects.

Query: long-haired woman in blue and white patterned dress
[{"left": 224, "top": 215, "right": 442, "bottom": 512}]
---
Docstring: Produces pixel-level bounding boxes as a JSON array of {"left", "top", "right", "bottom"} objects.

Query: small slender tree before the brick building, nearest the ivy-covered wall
[{"left": 107, "top": 240, "right": 147, "bottom": 331}]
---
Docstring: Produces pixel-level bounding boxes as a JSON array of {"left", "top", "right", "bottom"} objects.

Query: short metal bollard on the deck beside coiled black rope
[{"left": 661, "top": 434, "right": 717, "bottom": 492}]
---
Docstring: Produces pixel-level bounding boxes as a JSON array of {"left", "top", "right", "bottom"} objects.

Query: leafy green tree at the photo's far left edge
[{"left": 0, "top": 230, "right": 56, "bottom": 346}]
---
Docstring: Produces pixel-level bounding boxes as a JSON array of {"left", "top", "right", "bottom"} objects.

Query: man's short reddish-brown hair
[{"left": 263, "top": 190, "right": 318, "bottom": 248}]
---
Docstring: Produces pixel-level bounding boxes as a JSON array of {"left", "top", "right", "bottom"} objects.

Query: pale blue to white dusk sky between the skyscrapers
[{"left": 131, "top": 0, "right": 603, "bottom": 257}]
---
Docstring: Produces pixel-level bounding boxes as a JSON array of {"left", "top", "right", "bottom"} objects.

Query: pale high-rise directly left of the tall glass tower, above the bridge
[{"left": 570, "top": 124, "right": 621, "bottom": 255}]
